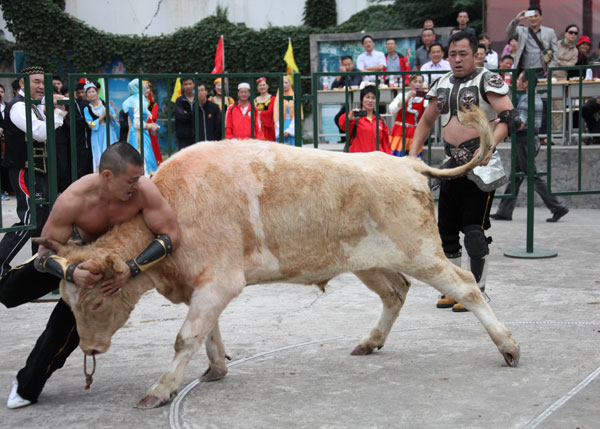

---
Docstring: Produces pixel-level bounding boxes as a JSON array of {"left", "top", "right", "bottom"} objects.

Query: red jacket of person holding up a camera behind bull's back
[{"left": 339, "top": 115, "right": 392, "bottom": 155}]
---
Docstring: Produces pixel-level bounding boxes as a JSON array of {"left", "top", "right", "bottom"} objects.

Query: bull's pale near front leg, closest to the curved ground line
[{"left": 136, "top": 278, "right": 245, "bottom": 408}]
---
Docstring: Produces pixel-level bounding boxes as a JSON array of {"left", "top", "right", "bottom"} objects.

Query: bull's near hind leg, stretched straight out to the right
[{"left": 408, "top": 259, "right": 520, "bottom": 367}]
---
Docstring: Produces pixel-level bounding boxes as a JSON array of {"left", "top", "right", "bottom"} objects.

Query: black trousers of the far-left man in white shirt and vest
[{"left": 0, "top": 167, "right": 50, "bottom": 276}]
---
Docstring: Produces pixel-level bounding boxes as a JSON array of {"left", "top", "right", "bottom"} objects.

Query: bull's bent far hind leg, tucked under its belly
[{"left": 352, "top": 269, "right": 410, "bottom": 355}]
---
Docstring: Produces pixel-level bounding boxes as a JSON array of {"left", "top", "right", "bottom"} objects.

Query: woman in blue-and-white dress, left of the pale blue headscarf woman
[{"left": 83, "top": 82, "right": 118, "bottom": 173}]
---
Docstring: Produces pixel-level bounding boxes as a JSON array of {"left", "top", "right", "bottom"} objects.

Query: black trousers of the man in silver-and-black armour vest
[{"left": 438, "top": 177, "right": 494, "bottom": 254}]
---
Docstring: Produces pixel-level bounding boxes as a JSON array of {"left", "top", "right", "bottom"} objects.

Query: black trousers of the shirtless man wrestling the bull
[{"left": 0, "top": 260, "right": 79, "bottom": 402}]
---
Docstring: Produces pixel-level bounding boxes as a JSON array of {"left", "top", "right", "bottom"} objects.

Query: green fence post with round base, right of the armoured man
[{"left": 504, "top": 69, "right": 558, "bottom": 259}]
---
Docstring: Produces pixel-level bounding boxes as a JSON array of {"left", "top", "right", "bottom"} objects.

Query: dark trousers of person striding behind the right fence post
[{"left": 496, "top": 131, "right": 565, "bottom": 217}]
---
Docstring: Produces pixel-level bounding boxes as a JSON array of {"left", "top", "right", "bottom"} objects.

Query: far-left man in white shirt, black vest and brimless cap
[{"left": 0, "top": 66, "right": 67, "bottom": 276}]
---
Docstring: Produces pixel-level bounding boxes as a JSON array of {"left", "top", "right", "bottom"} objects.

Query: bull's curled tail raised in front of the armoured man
[{"left": 414, "top": 106, "right": 494, "bottom": 179}]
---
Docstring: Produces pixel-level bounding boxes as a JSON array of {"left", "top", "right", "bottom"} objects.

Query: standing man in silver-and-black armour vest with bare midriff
[{"left": 410, "top": 31, "right": 520, "bottom": 311}]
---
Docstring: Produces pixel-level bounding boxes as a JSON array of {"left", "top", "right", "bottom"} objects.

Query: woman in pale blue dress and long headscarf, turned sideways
[{"left": 123, "top": 79, "right": 160, "bottom": 175}]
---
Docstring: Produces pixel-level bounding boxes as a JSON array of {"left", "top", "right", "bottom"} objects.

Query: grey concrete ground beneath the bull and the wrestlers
[{"left": 0, "top": 195, "right": 600, "bottom": 429}]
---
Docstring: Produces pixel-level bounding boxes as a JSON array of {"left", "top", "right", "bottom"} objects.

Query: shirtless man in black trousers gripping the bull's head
[{"left": 0, "top": 142, "right": 180, "bottom": 408}]
